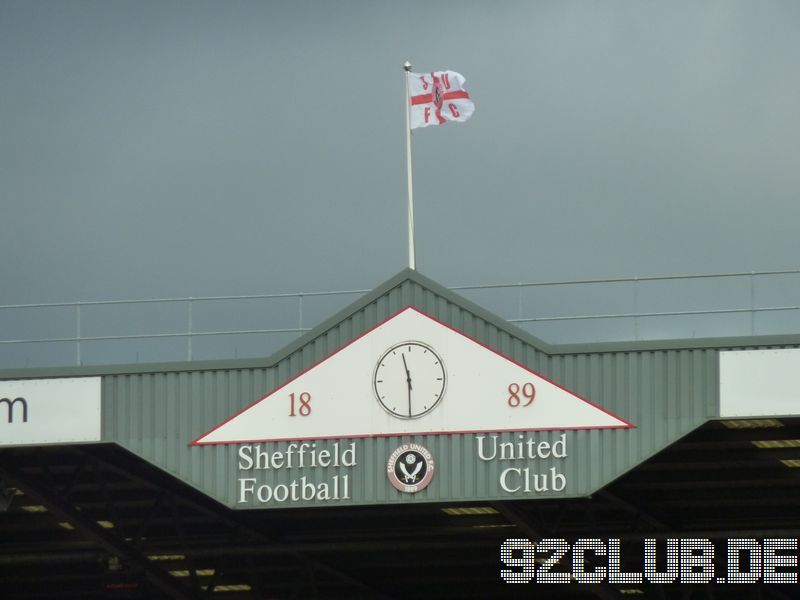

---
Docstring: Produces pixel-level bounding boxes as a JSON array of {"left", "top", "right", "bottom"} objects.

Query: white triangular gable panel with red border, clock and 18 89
[{"left": 193, "top": 308, "right": 632, "bottom": 444}]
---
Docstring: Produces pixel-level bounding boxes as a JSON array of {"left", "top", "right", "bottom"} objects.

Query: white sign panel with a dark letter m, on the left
[{"left": 0, "top": 377, "right": 100, "bottom": 446}]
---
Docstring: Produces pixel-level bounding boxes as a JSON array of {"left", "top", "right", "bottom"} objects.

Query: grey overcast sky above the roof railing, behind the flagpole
[{"left": 0, "top": 0, "right": 800, "bottom": 304}]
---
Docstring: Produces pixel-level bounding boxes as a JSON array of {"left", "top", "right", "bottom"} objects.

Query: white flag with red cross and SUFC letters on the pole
[{"left": 409, "top": 71, "right": 475, "bottom": 129}]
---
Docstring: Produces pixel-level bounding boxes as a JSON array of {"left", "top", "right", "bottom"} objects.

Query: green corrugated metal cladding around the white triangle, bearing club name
[{"left": 97, "top": 270, "right": 718, "bottom": 508}]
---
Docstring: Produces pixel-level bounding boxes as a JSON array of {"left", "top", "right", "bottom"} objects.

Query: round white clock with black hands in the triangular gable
[{"left": 372, "top": 341, "right": 447, "bottom": 419}]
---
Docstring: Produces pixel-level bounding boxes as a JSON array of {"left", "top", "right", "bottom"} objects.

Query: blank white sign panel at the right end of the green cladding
[{"left": 719, "top": 348, "right": 800, "bottom": 417}]
